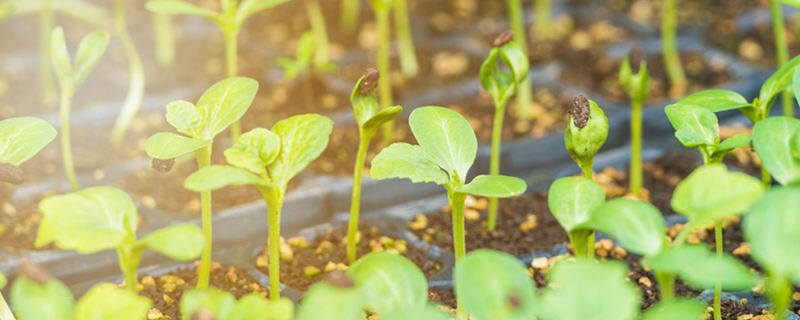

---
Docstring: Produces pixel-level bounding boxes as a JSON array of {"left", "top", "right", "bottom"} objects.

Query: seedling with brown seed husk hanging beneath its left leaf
[{"left": 145, "top": 78, "right": 258, "bottom": 288}]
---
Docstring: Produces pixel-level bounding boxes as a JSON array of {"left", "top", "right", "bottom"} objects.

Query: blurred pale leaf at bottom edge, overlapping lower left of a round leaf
[{"left": 295, "top": 282, "right": 364, "bottom": 320}]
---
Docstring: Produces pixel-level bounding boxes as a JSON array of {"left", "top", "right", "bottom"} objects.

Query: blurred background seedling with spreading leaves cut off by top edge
[{"left": 146, "top": 0, "right": 289, "bottom": 141}]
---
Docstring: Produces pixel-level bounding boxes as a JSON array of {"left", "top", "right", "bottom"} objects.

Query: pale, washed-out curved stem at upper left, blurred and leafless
[{"left": 111, "top": 0, "right": 145, "bottom": 143}]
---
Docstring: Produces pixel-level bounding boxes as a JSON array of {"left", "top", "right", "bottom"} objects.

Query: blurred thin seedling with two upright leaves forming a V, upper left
[{"left": 50, "top": 27, "right": 108, "bottom": 191}]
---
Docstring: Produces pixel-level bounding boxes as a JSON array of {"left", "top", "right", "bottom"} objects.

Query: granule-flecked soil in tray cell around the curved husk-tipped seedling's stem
[{"left": 254, "top": 223, "right": 442, "bottom": 291}]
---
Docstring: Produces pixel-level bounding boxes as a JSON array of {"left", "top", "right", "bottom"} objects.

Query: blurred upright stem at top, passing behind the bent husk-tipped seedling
[{"left": 375, "top": 9, "right": 394, "bottom": 145}]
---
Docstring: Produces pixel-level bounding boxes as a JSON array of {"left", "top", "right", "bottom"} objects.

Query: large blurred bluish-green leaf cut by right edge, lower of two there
[{"left": 742, "top": 187, "right": 800, "bottom": 282}]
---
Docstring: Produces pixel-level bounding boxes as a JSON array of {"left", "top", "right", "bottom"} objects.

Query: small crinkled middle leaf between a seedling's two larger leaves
[{"left": 225, "top": 128, "right": 281, "bottom": 175}]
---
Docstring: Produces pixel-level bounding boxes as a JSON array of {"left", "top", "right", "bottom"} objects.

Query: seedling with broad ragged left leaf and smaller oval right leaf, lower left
[{"left": 34, "top": 187, "right": 204, "bottom": 294}]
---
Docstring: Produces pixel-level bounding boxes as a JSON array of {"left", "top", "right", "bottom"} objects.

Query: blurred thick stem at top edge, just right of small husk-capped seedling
[{"left": 661, "top": 0, "right": 688, "bottom": 94}]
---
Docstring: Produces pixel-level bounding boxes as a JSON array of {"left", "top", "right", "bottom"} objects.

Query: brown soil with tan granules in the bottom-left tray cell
[{"left": 139, "top": 263, "right": 268, "bottom": 319}]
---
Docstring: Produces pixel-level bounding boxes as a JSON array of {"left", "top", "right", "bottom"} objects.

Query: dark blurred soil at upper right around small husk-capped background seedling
[{"left": 560, "top": 52, "right": 734, "bottom": 105}]
